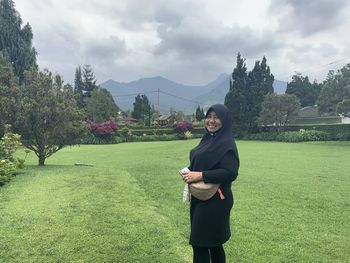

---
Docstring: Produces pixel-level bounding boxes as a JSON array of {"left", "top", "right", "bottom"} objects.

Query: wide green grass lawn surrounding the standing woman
[{"left": 0, "top": 140, "right": 350, "bottom": 263}]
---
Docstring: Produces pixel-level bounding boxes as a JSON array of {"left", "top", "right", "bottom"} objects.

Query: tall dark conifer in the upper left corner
[{"left": 0, "top": 0, "right": 36, "bottom": 83}]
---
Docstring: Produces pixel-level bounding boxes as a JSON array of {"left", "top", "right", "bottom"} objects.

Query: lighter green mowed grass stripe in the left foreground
[{"left": 0, "top": 166, "right": 190, "bottom": 262}]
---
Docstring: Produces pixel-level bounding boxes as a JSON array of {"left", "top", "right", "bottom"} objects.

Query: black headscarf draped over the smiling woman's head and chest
[{"left": 189, "top": 104, "right": 239, "bottom": 171}]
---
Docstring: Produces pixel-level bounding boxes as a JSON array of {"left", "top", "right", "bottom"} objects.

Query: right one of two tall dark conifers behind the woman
[{"left": 246, "top": 57, "right": 274, "bottom": 132}]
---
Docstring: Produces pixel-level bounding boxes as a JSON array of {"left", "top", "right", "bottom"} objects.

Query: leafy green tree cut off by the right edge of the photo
[{"left": 317, "top": 63, "right": 350, "bottom": 114}]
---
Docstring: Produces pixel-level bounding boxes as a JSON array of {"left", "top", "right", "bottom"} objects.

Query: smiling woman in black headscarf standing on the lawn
[{"left": 183, "top": 104, "right": 239, "bottom": 263}]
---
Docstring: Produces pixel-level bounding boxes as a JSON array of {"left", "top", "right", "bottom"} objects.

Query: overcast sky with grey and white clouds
[{"left": 14, "top": 0, "right": 350, "bottom": 85}]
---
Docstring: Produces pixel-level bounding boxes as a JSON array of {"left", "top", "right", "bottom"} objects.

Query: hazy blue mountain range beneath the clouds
[{"left": 100, "top": 73, "right": 287, "bottom": 114}]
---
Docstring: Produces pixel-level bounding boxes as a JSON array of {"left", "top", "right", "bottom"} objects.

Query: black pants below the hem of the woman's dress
[{"left": 192, "top": 245, "right": 226, "bottom": 263}]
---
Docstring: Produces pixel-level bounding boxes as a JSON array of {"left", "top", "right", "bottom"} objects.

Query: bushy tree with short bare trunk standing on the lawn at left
[{"left": 16, "top": 68, "right": 86, "bottom": 165}]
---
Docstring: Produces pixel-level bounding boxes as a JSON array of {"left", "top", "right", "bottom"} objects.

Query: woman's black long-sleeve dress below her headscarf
[{"left": 190, "top": 150, "right": 239, "bottom": 247}]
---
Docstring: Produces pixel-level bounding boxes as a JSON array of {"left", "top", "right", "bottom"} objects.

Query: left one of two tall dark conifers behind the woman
[{"left": 225, "top": 53, "right": 247, "bottom": 134}]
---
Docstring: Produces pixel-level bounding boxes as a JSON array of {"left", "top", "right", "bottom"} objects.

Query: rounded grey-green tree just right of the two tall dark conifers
[{"left": 259, "top": 93, "right": 300, "bottom": 126}]
